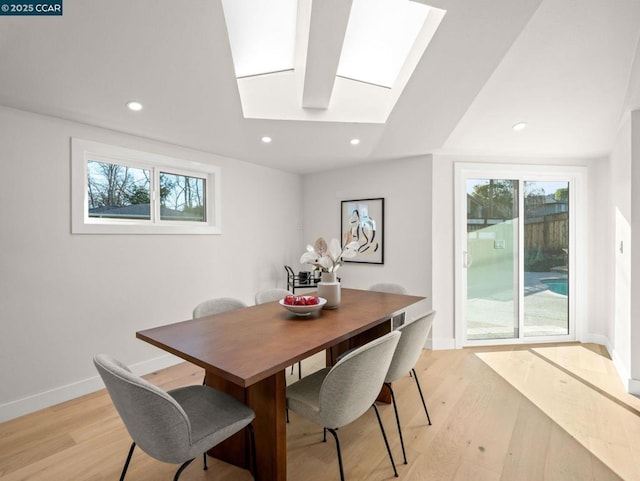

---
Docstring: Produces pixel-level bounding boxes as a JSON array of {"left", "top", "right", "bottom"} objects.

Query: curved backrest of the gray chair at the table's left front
[{"left": 93, "top": 354, "right": 191, "bottom": 463}]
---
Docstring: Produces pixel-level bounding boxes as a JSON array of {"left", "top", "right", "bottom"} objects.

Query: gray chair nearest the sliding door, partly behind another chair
[{"left": 384, "top": 311, "right": 436, "bottom": 464}]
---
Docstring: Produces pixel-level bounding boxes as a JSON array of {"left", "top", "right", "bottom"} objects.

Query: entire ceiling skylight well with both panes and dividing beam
[{"left": 221, "top": 0, "right": 446, "bottom": 123}]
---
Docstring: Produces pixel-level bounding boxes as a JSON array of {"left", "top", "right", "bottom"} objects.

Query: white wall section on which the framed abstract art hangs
[{"left": 302, "top": 156, "right": 432, "bottom": 324}]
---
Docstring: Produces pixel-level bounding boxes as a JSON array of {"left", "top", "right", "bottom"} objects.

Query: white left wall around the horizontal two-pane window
[{"left": 0, "top": 108, "right": 305, "bottom": 422}]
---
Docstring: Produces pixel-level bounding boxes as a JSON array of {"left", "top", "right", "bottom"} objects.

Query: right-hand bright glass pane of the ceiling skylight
[{"left": 337, "top": 0, "right": 429, "bottom": 88}]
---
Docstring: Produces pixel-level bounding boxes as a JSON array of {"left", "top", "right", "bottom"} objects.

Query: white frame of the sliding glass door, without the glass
[{"left": 454, "top": 162, "right": 588, "bottom": 348}]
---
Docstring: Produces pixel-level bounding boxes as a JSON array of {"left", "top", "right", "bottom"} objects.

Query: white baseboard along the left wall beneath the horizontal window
[{"left": 0, "top": 354, "right": 182, "bottom": 423}]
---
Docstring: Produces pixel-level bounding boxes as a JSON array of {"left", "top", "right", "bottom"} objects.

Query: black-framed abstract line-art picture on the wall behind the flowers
[{"left": 340, "top": 197, "right": 384, "bottom": 264}]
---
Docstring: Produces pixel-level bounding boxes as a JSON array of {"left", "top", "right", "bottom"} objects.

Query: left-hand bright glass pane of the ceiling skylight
[{"left": 222, "top": 0, "right": 298, "bottom": 78}]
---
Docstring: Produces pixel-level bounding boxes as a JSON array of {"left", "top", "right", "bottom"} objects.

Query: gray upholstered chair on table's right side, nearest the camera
[{"left": 287, "top": 331, "right": 400, "bottom": 481}]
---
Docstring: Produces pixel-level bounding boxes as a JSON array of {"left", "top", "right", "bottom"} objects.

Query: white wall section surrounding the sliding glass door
[{"left": 432, "top": 154, "right": 609, "bottom": 349}]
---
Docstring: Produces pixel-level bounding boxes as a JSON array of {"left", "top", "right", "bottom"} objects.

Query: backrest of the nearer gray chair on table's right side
[{"left": 320, "top": 331, "right": 400, "bottom": 429}]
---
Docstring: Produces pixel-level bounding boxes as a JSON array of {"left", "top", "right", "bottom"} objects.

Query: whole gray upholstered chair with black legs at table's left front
[{"left": 93, "top": 354, "right": 256, "bottom": 481}]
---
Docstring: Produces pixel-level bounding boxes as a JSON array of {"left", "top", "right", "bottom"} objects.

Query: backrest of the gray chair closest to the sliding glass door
[{"left": 385, "top": 311, "right": 436, "bottom": 382}]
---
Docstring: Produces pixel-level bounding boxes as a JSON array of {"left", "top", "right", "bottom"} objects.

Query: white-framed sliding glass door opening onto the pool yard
[{"left": 456, "top": 165, "right": 575, "bottom": 345}]
